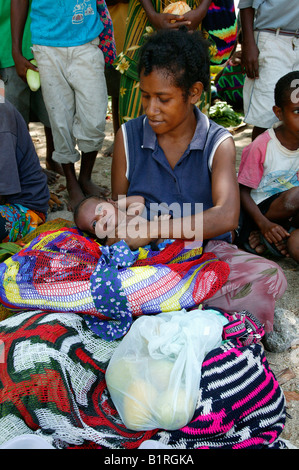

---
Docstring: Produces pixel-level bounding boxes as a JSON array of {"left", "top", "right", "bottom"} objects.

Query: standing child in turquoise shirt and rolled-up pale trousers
[{"left": 11, "top": 0, "right": 108, "bottom": 208}]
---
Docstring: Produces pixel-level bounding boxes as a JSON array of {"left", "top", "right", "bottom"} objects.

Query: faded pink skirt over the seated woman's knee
[{"left": 204, "top": 240, "right": 287, "bottom": 332}]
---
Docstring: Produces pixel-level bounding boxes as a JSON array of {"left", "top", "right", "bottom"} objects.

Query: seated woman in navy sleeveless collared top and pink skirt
[{"left": 110, "top": 27, "right": 286, "bottom": 331}]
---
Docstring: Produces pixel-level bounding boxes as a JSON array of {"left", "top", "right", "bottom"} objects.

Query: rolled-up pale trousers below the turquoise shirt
[{"left": 33, "top": 38, "right": 108, "bottom": 163}]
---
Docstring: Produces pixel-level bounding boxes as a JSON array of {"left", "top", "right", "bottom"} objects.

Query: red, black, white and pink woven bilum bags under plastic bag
[{"left": 0, "top": 311, "right": 285, "bottom": 450}]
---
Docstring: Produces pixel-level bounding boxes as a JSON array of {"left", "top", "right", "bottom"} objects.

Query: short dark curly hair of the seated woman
[{"left": 138, "top": 27, "right": 210, "bottom": 98}]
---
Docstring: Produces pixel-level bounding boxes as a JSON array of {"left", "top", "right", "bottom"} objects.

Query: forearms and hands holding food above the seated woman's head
[{"left": 140, "top": 0, "right": 211, "bottom": 30}]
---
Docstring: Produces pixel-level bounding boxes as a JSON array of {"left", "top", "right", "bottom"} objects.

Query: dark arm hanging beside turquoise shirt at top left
[{"left": 10, "top": 0, "right": 37, "bottom": 83}]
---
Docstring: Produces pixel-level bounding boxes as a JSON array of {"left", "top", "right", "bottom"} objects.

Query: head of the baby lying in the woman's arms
[{"left": 74, "top": 196, "right": 118, "bottom": 244}]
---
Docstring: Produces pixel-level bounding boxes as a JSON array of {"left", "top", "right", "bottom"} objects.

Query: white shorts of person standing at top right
[{"left": 243, "top": 31, "right": 299, "bottom": 129}]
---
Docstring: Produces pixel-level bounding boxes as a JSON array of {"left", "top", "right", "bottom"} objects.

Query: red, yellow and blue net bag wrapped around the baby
[{"left": 0, "top": 228, "right": 229, "bottom": 340}]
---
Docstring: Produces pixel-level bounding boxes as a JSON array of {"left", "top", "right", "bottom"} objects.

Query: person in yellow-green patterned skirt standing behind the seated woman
[{"left": 116, "top": 0, "right": 237, "bottom": 123}]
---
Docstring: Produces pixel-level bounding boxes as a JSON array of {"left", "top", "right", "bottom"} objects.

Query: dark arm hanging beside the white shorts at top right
[{"left": 240, "top": 7, "right": 259, "bottom": 78}]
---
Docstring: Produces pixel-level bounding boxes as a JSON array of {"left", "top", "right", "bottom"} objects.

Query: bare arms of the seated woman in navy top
[{"left": 108, "top": 129, "right": 240, "bottom": 249}]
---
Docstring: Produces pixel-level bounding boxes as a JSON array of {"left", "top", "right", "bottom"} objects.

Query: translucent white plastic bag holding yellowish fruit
[{"left": 106, "top": 309, "right": 226, "bottom": 431}]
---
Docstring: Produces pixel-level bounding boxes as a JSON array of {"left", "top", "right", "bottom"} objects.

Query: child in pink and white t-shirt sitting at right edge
[{"left": 238, "top": 71, "right": 299, "bottom": 263}]
